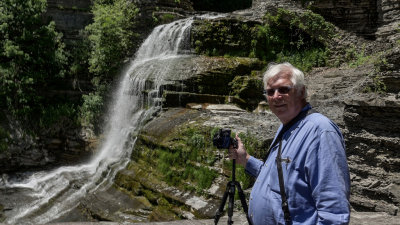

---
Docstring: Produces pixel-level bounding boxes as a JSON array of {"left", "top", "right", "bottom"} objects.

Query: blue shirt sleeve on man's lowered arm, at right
[{"left": 306, "top": 131, "right": 350, "bottom": 224}]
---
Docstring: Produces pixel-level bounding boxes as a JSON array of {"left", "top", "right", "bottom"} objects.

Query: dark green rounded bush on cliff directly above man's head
[{"left": 253, "top": 9, "right": 335, "bottom": 71}]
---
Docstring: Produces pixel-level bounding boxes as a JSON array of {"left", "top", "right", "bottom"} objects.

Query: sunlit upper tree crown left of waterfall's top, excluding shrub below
[{"left": 85, "top": 0, "right": 138, "bottom": 78}]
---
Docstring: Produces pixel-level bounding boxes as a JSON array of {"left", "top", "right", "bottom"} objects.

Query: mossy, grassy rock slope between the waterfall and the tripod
[{"left": 115, "top": 113, "right": 265, "bottom": 220}]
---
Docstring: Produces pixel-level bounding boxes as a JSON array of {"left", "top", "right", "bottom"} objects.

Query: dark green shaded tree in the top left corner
[{"left": 0, "top": 0, "right": 67, "bottom": 123}]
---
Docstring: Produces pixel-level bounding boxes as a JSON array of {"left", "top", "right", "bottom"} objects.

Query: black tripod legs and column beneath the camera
[{"left": 214, "top": 159, "right": 253, "bottom": 225}]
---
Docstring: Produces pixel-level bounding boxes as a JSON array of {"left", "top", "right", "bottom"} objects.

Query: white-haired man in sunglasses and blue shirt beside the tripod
[{"left": 229, "top": 63, "right": 350, "bottom": 225}]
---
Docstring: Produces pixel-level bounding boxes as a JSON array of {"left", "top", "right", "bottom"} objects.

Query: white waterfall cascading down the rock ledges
[{"left": 0, "top": 18, "right": 192, "bottom": 224}]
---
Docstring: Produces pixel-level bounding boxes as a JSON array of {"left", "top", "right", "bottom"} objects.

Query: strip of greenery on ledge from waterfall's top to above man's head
[{"left": 192, "top": 9, "right": 335, "bottom": 71}]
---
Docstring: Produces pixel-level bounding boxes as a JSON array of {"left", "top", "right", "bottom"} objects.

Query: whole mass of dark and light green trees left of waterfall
[{"left": 0, "top": 0, "right": 138, "bottom": 135}]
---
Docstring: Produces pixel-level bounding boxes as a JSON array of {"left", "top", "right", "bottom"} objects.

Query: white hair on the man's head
[{"left": 263, "top": 62, "right": 307, "bottom": 99}]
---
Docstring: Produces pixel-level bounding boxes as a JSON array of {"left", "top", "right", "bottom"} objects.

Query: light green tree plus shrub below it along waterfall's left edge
[{"left": 79, "top": 0, "right": 138, "bottom": 129}]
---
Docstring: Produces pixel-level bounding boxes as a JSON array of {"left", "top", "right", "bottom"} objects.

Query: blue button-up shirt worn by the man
[{"left": 246, "top": 105, "right": 350, "bottom": 225}]
